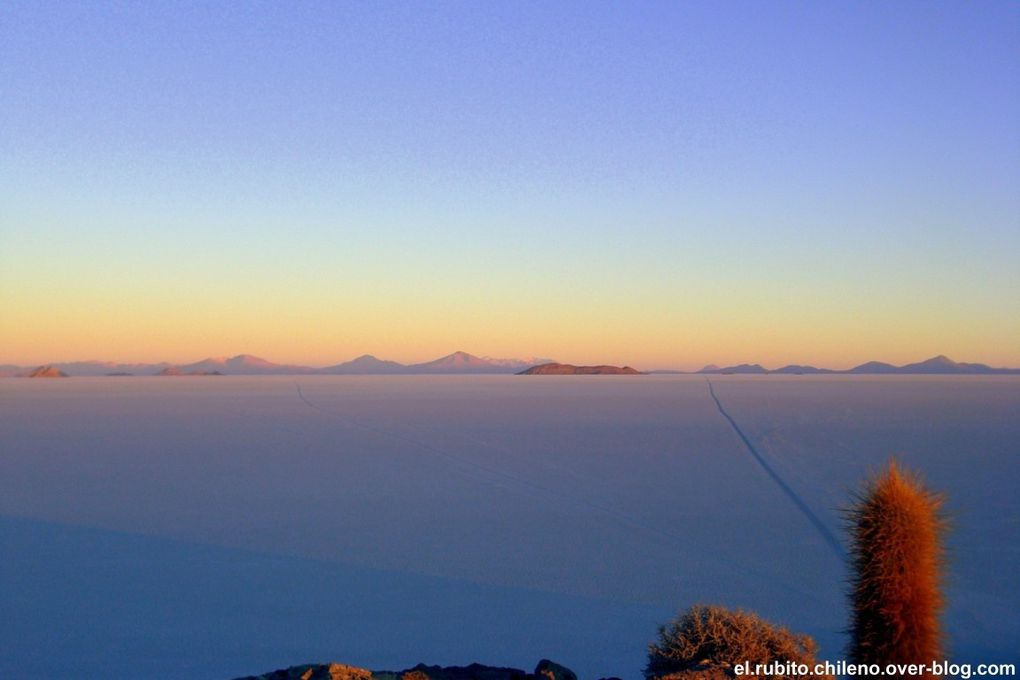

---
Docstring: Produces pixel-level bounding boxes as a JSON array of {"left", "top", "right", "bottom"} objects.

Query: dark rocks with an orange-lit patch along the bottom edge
[{"left": 237, "top": 659, "right": 577, "bottom": 680}]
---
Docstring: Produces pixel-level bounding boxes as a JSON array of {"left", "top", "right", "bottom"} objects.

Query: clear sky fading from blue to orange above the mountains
[{"left": 0, "top": 0, "right": 1020, "bottom": 369}]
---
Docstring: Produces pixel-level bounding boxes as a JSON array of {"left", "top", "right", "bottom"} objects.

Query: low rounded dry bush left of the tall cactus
[{"left": 645, "top": 606, "right": 817, "bottom": 680}]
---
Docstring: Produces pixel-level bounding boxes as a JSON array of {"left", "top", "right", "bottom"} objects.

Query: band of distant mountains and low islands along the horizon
[{"left": 0, "top": 352, "right": 1020, "bottom": 377}]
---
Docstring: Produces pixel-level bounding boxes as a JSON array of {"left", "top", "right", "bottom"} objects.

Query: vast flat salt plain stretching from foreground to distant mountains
[{"left": 0, "top": 375, "right": 1020, "bottom": 678}]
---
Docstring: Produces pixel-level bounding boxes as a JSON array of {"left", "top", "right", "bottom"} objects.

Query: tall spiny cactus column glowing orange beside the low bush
[{"left": 849, "top": 461, "right": 946, "bottom": 665}]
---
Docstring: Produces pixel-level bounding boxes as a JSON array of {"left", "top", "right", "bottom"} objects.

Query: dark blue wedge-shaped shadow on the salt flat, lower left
[{"left": 0, "top": 517, "right": 673, "bottom": 680}]
